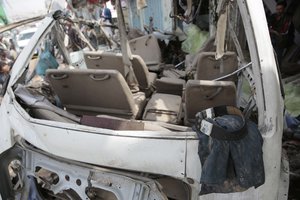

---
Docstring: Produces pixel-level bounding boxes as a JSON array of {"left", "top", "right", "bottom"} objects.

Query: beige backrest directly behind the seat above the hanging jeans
[{"left": 195, "top": 52, "right": 238, "bottom": 81}]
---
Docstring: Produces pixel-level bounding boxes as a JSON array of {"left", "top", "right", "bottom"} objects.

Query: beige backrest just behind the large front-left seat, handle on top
[{"left": 84, "top": 51, "right": 125, "bottom": 77}]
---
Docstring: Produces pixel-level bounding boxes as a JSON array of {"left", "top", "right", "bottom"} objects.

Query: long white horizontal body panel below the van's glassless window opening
[{"left": 5, "top": 99, "right": 201, "bottom": 181}]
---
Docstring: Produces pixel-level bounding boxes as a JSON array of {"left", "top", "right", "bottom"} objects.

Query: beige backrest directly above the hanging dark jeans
[{"left": 185, "top": 80, "right": 236, "bottom": 125}]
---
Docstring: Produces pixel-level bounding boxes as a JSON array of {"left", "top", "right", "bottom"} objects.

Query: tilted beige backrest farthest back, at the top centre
[{"left": 129, "top": 34, "right": 161, "bottom": 65}]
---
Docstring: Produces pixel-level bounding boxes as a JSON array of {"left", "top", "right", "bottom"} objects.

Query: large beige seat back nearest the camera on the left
[{"left": 46, "top": 69, "right": 146, "bottom": 118}]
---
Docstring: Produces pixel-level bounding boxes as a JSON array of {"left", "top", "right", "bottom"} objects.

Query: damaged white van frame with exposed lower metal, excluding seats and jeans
[{"left": 0, "top": 0, "right": 288, "bottom": 200}]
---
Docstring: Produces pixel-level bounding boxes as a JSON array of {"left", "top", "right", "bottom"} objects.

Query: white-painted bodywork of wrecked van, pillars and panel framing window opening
[{"left": 0, "top": 0, "right": 283, "bottom": 200}]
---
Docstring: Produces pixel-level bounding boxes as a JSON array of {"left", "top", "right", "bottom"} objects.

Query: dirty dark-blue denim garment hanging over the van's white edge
[{"left": 194, "top": 115, "right": 265, "bottom": 194}]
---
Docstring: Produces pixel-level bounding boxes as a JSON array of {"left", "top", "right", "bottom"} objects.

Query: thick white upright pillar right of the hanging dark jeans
[{"left": 238, "top": 0, "right": 283, "bottom": 200}]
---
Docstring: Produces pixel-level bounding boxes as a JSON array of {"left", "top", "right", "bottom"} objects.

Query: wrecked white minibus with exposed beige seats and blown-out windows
[{"left": 0, "top": 0, "right": 289, "bottom": 200}]
